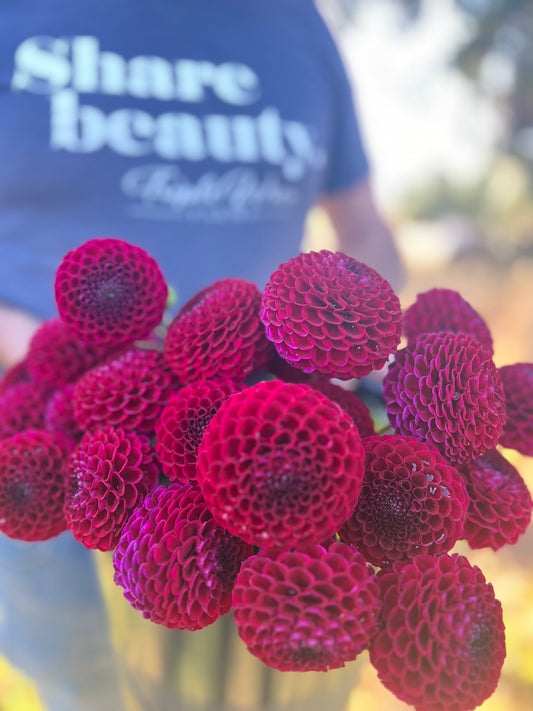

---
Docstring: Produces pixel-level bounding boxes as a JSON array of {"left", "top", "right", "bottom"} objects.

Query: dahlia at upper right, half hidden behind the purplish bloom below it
[{"left": 402, "top": 289, "right": 493, "bottom": 357}]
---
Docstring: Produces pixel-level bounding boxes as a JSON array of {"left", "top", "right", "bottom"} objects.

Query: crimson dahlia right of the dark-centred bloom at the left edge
[{"left": 65, "top": 427, "right": 158, "bottom": 551}]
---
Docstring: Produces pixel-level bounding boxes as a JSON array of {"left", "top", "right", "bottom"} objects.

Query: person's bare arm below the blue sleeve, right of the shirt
[{"left": 319, "top": 178, "right": 405, "bottom": 292}]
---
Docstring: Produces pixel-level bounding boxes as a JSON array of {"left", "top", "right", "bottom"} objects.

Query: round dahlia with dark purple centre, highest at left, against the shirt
[{"left": 55, "top": 238, "right": 168, "bottom": 346}]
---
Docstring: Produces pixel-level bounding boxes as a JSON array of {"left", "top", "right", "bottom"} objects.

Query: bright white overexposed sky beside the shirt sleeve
[{"left": 337, "top": 0, "right": 504, "bottom": 209}]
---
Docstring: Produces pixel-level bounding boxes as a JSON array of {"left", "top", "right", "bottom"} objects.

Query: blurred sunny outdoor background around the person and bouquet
[{"left": 0, "top": 0, "right": 533, "bottom": 711}]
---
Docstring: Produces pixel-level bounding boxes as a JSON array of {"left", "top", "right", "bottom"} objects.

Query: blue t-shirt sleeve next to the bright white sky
[{"left": 313, "top": 4, "right": 369, "bottom": 194}]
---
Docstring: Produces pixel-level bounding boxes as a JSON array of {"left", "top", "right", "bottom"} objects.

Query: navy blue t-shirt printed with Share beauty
[{"left": 0, "top": 0, "right": 368, "bottom": 318}]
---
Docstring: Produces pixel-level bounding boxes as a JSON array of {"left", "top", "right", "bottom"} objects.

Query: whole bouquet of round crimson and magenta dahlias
[{"left": 0, "top": 238, "right": 533, "bottom": 711}]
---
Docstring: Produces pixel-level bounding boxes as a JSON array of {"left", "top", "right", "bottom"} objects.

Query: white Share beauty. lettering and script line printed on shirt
[{"left": 11, "top": 35, "right": 325, "bottom": 220}]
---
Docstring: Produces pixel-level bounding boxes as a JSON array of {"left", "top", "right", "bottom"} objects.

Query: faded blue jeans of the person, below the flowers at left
[{"left": 0, "top": 531, "right": 124, "bottom": 711}]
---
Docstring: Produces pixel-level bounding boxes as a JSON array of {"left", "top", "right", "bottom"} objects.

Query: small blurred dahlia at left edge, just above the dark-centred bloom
[{"left": 0, "top": 381, "right": 52, "bottom": 441}]
